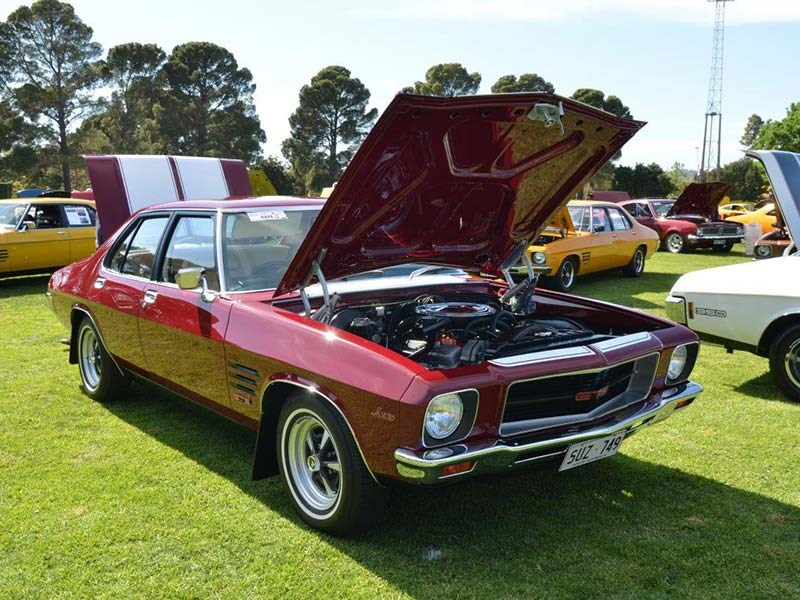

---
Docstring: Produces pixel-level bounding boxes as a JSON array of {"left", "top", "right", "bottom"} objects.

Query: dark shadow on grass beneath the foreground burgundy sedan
[{"left": 109, "top": 385, "right": 800, "bottom": 599}]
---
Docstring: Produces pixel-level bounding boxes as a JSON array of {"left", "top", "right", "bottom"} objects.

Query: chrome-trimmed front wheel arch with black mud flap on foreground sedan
[{"left": 253, "top": 378, "right": 380, "bottom": 485}]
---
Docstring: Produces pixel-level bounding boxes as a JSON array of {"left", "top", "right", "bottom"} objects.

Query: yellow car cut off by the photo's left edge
[{"left": 0, "top": 198, "right": 97, "bottom": 276}]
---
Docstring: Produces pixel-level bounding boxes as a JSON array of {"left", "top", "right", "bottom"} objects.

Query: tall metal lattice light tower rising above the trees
[{"left": 698, "top": 0, "right": 733, "bottom": 181}]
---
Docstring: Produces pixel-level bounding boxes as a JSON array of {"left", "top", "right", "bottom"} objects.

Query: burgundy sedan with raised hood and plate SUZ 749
[{"left": 49, "top": 94, "right": 702, "bottom": 534}]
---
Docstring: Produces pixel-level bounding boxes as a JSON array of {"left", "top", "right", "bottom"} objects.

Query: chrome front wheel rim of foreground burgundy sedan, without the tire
[{"left": 284, "top": 411, "right": 342, "bottom": 515}]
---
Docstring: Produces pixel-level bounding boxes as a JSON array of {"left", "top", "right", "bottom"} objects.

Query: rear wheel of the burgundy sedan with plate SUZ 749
[{"left": 76, "top": 317, "right": 127, "bottom": 403}]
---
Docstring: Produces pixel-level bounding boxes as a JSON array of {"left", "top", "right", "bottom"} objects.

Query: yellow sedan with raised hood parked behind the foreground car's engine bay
[{"left": 519, "top": 200, "right": 659, "bottom": 292}]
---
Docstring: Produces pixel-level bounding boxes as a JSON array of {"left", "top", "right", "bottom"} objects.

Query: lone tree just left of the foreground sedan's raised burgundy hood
[{"left": 282, "top": 66, "right": 378, "bottom": 191}]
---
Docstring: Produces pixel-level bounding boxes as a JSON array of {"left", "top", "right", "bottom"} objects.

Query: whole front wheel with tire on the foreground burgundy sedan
[{"left": 276, "top": 393, "right": 388, "bottom": 535}]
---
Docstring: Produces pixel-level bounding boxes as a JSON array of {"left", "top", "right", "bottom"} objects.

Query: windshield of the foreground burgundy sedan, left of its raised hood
[{"left": 222, "top": 206, "right": 320, "bottom": 292}]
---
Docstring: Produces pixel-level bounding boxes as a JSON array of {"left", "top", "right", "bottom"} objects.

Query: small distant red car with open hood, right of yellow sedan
[{"left": 620, "top": 183, "right": 744, "bottom": 253}]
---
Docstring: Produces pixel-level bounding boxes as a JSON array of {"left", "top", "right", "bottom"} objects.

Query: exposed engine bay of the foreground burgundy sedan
[{"left": 330, "top": 293, "right": 614, "bottom": 369}]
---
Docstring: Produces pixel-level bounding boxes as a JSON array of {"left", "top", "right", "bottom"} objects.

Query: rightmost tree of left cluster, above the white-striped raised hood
[{"left": 156, "top": 42, "right": 267, "bottom": 162}]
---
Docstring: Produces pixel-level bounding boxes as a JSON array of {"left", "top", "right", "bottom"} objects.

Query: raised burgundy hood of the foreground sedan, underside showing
[{"left": 275, "top": 93, "right": 644, "bottom": 295}]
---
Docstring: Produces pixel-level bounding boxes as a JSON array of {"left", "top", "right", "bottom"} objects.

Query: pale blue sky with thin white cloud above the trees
[{"left": 0, "top": 0, "right": 800, "bottom": 168}]
